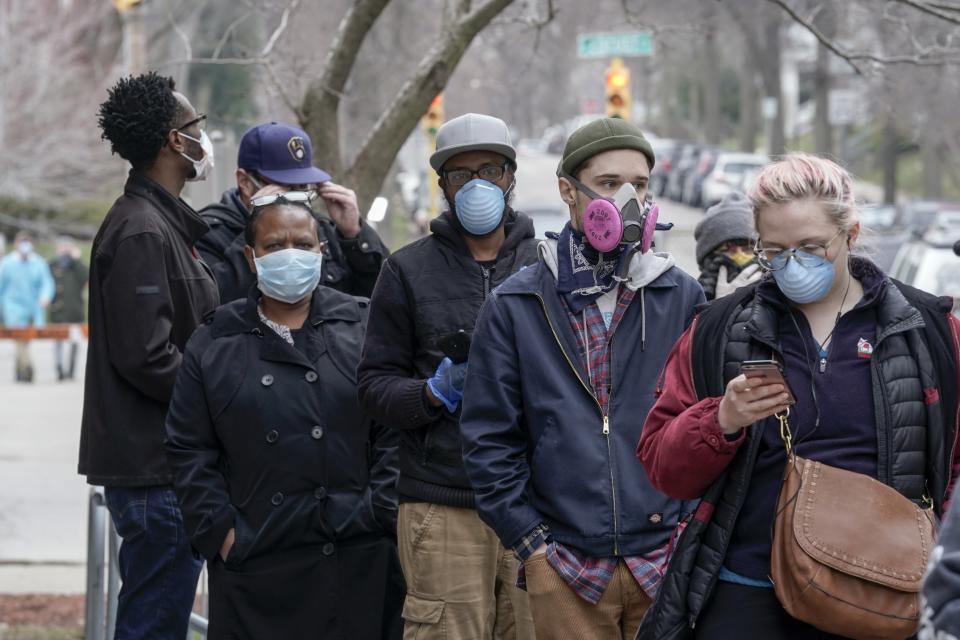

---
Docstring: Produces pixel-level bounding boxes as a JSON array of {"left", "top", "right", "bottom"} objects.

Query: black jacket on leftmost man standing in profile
[{"left": 79, "top": 171, "right": 218, "bottom": 486}]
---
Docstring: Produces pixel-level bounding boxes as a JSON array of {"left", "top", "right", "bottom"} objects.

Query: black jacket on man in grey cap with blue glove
[{"left": 357, "top": 210, "right": 537, "bottom": 508}]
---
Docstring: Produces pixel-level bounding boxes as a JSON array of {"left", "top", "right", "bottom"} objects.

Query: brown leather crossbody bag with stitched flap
[{"left": 770, "top": 412, "right": 937, "bottom": 640}]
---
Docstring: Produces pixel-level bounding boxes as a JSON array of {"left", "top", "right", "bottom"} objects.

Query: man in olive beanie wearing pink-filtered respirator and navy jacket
[{"left": 460, "top": 118, "right": 704, "bottom": 640}]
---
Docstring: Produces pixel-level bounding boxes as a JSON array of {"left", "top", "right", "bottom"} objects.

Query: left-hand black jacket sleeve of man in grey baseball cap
[{"left": 357, "top": 260, "right": 440, "bottom": 429}]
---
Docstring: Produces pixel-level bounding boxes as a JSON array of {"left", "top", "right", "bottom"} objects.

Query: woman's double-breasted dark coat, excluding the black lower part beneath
[{"left": 166, "top": 287, "right": 398, "bottom": 566}]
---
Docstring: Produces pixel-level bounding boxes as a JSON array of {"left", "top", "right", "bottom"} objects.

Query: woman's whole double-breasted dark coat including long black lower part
[{"left": 166, "top": 287, "right": 403, "bottom": 640}]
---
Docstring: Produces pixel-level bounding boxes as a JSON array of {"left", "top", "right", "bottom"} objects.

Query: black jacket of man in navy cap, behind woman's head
[{"left": 197, "top": 187, "right": 390, "bottom": 302}]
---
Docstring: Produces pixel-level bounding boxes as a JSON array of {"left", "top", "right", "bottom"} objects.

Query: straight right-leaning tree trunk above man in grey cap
[{"left": 344, "top": 0, "right": 513, "bottom": 210}]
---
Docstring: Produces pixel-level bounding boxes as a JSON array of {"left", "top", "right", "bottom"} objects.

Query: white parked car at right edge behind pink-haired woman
[{"left": 890, "top": 226, "right": 960, "bottom": 317}]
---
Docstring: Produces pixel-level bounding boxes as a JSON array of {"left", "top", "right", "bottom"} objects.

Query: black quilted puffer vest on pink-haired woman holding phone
[{"left": 637, "top": 262, "right": 957, "bottom": 640}]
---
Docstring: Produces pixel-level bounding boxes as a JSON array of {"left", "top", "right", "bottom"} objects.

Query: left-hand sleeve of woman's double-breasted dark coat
[{"left": 164, "top": 330, "right": 236, "bottom": 560}]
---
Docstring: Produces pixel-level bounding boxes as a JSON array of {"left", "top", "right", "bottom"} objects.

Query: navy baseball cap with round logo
[{"left": 237, "top": 122, "right": 330, "bottom": 184}]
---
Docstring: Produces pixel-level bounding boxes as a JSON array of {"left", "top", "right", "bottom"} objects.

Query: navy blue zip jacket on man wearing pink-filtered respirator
[{"left": 460, "top": 252, "right": 704, "bottom": 558}]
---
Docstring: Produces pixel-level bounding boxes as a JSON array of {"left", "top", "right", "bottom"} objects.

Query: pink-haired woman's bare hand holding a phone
[{"left": 717, "top": 360, "right": 796, "bottom": 434}]
